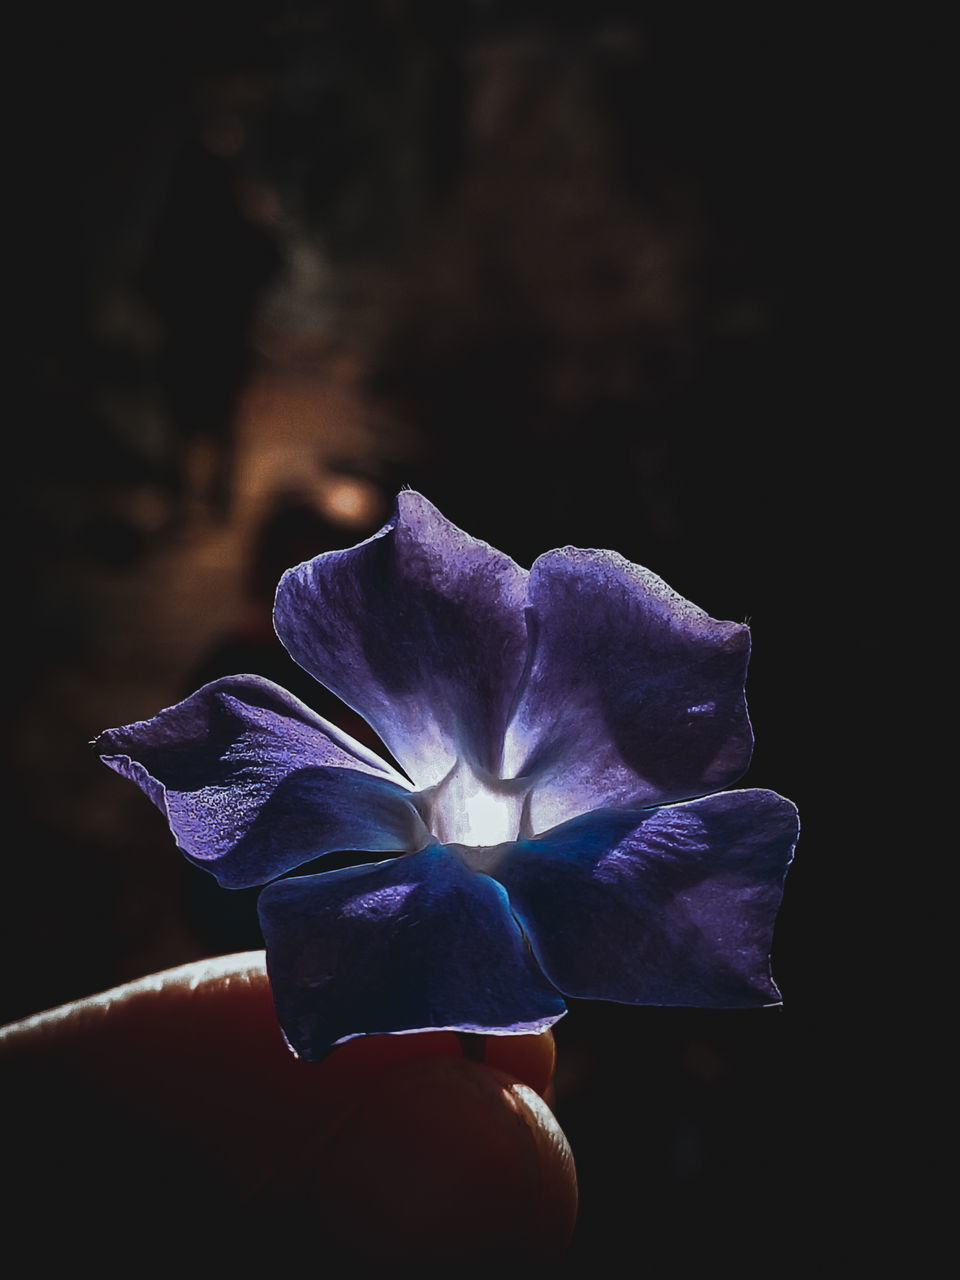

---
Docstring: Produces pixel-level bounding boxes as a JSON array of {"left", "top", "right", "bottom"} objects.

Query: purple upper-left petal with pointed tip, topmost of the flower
[{"left": 274, "top": 492, "right": 527, "bottom": 787}]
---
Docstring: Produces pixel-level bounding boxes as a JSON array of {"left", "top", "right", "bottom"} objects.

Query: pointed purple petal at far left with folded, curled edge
[{"left": 95, "top": 676, "right": 428, "bottom": 888}]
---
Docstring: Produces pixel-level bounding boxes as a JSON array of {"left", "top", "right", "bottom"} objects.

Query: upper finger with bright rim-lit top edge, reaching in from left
[{"left": 0, "top": 952, "right": 556, "bottom": 1198}]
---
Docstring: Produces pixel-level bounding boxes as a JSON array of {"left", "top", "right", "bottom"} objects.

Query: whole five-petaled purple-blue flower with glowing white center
[{"left": 96, "top": 492, "right": 799, "bottom": 1059}]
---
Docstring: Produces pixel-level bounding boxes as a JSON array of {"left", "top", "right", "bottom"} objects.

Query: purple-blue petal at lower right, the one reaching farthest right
[{"left": 497, "top": 790, "right": 799, "bottom": 1006}]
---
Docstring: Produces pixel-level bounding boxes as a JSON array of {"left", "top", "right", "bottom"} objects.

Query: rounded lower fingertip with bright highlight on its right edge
[{"left": 261, "top": 1057, "right": 577, "bottom": 1258}]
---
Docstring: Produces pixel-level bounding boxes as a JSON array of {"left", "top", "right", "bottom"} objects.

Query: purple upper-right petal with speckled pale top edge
[{"left": 504, "top": 548, "right": 753, "bottom": 833}]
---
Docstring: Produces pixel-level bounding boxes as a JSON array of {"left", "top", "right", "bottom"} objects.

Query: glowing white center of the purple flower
[{"left": 420, "top": 759, "right": 529, "bottom": 847}]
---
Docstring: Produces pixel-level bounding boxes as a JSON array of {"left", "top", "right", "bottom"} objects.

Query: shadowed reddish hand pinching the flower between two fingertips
[{"left": 0, "top": 952, "right": 576, "bottom": 1249}]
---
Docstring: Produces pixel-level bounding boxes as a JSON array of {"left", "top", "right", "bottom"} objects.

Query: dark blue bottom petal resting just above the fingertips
[{"left": 259, "top": 845, "right": 564, "bottom": 1060}]
